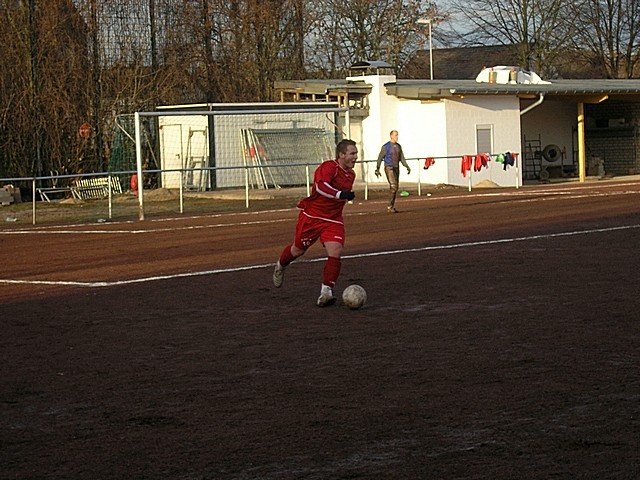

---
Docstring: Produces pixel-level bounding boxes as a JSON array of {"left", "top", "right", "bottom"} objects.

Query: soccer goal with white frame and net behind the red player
[{"left": 135, "top": 102, "right": 350, "bottom": 220}]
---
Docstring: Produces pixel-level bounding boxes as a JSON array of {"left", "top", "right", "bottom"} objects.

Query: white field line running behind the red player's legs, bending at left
[{"left": 0, "top": 224, "right": 640, "bottom": 288}]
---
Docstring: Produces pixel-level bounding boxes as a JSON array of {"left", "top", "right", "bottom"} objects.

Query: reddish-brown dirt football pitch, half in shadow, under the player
[{"left": 0, "top": 179, "right": 640, "bottom": 480}]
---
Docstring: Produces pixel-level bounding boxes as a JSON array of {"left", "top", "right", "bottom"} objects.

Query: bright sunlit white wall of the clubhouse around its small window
[{"left": 357, "top": 80, "right": 522, "bottom": 186}]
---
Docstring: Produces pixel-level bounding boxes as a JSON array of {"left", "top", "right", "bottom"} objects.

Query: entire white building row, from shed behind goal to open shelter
[{"left": 152, "top": 62, "right": 640, "bottom": 190}]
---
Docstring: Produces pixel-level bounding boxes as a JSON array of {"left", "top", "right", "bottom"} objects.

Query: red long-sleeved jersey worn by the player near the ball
[{"left": 298, "top": 160, "right": 356, "bottom": 223}]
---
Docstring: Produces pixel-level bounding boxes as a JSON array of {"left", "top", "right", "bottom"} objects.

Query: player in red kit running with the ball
[{"left": 273, "top": 140, "right": 358, "bottom": 307}]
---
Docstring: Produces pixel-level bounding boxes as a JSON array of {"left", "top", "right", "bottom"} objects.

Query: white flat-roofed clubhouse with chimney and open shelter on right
[{"left": 276, "top": 62, "right": 640, "bottom": 186}]
